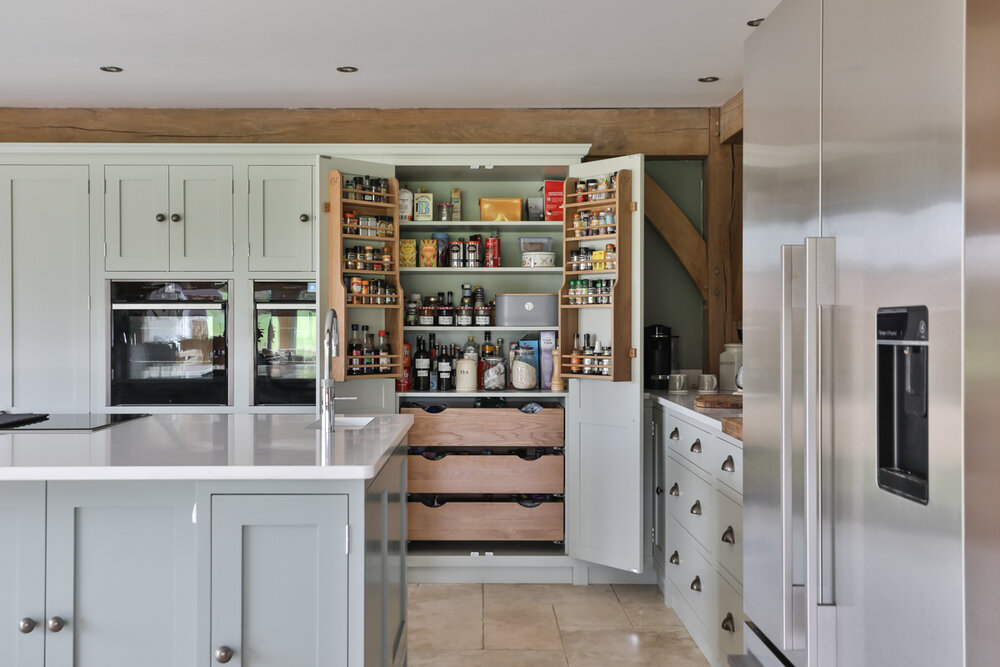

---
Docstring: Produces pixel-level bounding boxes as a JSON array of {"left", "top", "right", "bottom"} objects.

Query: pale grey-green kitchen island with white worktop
[{"left": 0, "top": 414, "right": 412, "bottom": 667}]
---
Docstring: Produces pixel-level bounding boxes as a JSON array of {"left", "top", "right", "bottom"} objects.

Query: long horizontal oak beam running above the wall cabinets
[{"left": 0, "top": 107, "right": 710, "bottom": 159}]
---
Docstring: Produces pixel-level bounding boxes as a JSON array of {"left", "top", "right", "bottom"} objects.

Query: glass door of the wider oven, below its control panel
[{"left": 110, "top": 303, "right": 229, "bottom": 405}]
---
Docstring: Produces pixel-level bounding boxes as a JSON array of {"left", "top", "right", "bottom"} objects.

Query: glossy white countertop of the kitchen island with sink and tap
[{"left": 0, "top": 414, "right": 413, "bottom": 480}]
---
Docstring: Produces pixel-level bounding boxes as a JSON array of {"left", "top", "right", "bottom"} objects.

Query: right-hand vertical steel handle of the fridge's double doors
[{"left": 803, "top": 237, "right": 836, "bottom": 667}]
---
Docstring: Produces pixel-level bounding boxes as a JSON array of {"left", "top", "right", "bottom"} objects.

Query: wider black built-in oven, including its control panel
[{"left": 108, "top": 280, "right": 233, "bottom": 405}]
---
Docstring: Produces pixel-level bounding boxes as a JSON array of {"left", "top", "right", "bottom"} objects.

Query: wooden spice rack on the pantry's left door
[{"left": 328, "top": 171, "right": 403, "bottom": 382}]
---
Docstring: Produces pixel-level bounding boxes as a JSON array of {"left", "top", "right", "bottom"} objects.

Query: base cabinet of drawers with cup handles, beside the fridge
[{"left": 652, "top": 403, "right": 743, "bottom": 666}]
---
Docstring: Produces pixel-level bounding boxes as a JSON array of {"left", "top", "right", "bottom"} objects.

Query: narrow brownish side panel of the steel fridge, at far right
[{"left": 964, "top": 0, "right": 1000, "bottom": 666}]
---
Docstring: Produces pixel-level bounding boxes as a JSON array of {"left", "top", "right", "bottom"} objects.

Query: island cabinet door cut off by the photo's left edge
[{"left": 0, "top": 482, "right": 45, "bottom": 667}]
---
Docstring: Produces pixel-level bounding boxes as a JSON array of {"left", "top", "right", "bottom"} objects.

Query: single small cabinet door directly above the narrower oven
[{"left": 249, "top": 165, "right": 315, "bottom": 271}]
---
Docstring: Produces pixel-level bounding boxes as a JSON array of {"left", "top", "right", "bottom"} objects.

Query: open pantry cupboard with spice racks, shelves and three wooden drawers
[{"left": 319, "top": 145, "right": 648, "bottom": 583}]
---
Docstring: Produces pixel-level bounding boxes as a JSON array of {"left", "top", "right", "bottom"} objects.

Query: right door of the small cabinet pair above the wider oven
[{"left": 170, "top": 166, "right": 233, "bottom": 271}]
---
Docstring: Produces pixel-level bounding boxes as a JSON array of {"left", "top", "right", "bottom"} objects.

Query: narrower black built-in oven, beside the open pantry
[{"left": 253, "top": 281, "right": 318, "bottom": 405}]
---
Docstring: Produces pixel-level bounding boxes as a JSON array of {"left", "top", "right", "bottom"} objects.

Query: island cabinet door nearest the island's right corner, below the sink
[{"left": 212, "top": 495, "right": 348, "bottom": 667}]
